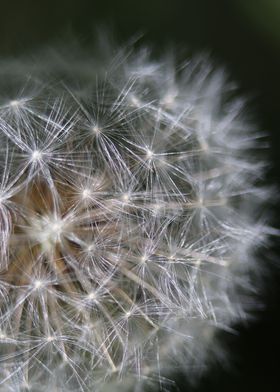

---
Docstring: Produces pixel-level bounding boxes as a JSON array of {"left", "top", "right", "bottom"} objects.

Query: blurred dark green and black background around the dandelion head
[{"left": 0, "top": 0, "right": 280, "bottom": 392}]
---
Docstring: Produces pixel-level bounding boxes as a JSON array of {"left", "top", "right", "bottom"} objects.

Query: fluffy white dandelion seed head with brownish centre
[{"left": 0, "top": 43, "right": 269, "bottom": 391}]
